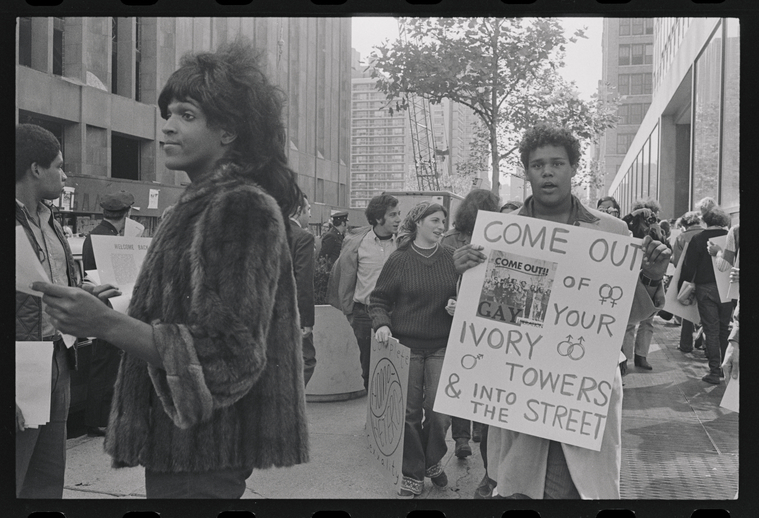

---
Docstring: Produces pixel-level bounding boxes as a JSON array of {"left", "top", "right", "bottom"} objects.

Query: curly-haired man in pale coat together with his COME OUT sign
[{"left": 436, "top": 124, "right": 670, "bottom": 499}]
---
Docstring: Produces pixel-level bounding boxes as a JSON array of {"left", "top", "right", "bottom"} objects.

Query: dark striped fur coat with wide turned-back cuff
[{"left": 105, "top": 166, "right": 308, "bottom": 472}]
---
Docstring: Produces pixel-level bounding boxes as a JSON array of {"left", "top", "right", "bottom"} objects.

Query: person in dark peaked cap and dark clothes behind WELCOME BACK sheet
[{"left": 82, "top": 191, "right": 134, "bottom": 437}]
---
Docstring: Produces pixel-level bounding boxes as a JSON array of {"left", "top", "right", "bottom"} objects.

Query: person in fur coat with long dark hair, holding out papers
[{"left": 35, "top": 41, "right": 308, "bottom": 498}]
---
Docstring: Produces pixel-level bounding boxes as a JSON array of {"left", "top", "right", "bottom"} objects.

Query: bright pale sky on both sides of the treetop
[{"left": 352, "top": 17, "right": 603, "bottom": 99}]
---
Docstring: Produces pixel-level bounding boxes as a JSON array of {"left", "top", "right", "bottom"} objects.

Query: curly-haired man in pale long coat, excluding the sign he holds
[{"left": 454, "top": 124, "right": 671, "bottom": 499}]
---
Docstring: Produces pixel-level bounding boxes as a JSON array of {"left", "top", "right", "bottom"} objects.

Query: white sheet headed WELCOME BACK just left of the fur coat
[{"left": 90, "top": 235, "right": 152, "bottom": 313}]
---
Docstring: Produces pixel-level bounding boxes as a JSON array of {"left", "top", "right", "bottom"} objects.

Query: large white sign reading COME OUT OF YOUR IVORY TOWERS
[{"left": 435, "top": 211, "right": 643, "bottom": 450}]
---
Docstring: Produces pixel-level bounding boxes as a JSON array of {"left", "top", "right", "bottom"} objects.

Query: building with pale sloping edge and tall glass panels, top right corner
[{"left": 609, "top": 18, "right": 740, "bottom": 221}]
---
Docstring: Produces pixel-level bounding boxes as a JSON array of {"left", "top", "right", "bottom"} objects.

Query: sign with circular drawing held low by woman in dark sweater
[{"left": 365, "top": 336, "right": 411, "bottom": 490}]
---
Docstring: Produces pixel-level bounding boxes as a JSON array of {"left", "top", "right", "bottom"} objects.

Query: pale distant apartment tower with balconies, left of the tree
[{"left": 350, "top": 50, "right": 413, "bottom": 209}]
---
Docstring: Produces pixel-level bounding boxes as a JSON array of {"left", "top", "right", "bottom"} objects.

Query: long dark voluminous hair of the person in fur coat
[{"left": 158, "top": 37, "right": 302, "bottom": 216}]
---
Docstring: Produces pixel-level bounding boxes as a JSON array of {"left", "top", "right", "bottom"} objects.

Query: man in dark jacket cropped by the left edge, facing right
[{"left": 16, "top": 124, "right": 116, "bottom": 498}]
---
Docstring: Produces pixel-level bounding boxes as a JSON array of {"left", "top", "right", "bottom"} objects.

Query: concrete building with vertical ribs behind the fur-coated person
[{"left": 16, "top": 17, "right": 354, "bottom": 235}]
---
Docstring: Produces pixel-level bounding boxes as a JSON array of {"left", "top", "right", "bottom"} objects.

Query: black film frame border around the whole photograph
[{"left": 5, "top": 0, "right": 759, "bottom": 518}]
